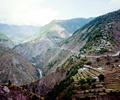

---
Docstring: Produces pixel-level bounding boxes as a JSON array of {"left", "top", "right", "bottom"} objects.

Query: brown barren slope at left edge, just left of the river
[{"left": 0, "top": 46, "right": 38, "bottom": 85}]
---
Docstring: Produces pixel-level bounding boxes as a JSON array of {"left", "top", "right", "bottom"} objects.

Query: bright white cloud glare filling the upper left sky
[{"left": 0, "top": 0, "right": 59, "bottom": 25}]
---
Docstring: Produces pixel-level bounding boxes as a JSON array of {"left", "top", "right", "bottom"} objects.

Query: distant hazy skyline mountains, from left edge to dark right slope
[{"left": 0, "top": 18, "right": 93, "bottom": 44}]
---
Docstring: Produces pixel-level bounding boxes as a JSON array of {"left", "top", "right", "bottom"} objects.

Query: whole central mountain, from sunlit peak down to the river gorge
[{"left": 14, "top": 18, "right": 93, "bottom": 74}]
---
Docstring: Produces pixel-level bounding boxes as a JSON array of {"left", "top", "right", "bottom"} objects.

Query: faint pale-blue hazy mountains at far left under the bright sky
[{"left": 0, "top": 23, "right": 40, "bottom": 44}]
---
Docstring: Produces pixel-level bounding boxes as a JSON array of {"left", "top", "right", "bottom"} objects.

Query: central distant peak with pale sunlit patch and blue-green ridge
[{"left": 38, "top": 18, "right": 93, "bottom": 43}]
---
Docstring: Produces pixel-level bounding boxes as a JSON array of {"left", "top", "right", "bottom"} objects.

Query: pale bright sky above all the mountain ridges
[{"left": 0, "top": 0, "right": 120, "bottom": 26}]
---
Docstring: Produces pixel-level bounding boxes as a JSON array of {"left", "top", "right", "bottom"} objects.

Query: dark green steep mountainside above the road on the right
[{"left": 63, "top": 10, "right": 120, "bottom": 54}]
